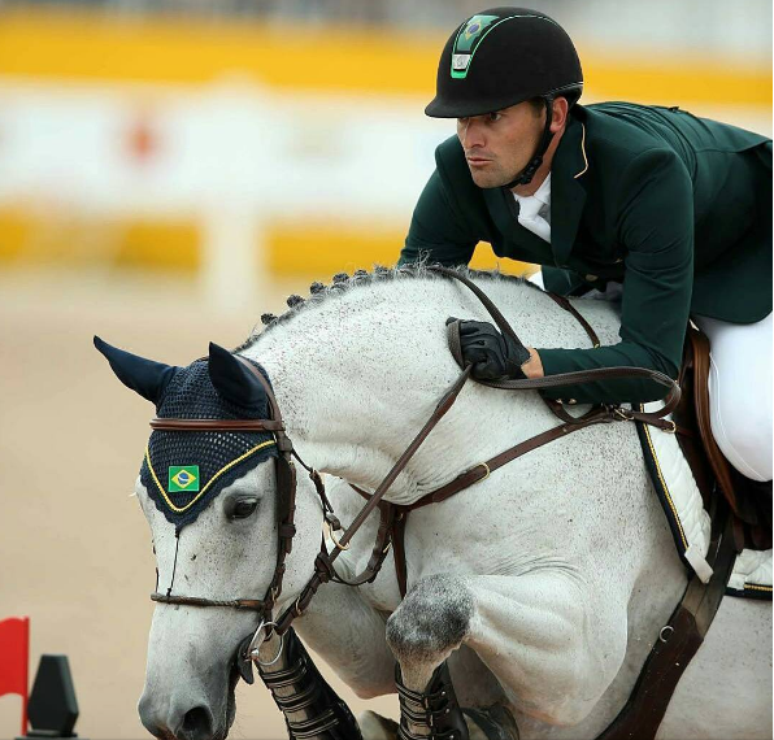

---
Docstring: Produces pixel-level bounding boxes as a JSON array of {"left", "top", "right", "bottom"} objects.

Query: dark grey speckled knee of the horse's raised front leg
[{"left": 387, "top": 575, "right": 474, "bottom": 663}]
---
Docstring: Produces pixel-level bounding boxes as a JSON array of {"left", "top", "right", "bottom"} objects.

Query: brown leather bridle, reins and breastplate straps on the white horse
[{"left": 150, "top": 266, "right": 680, "bottom": 682}]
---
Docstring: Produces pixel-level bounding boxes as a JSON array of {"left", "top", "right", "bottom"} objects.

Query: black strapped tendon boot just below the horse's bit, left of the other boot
[{"left": 258, "top": 629, "right": 363, "bottom": 740}]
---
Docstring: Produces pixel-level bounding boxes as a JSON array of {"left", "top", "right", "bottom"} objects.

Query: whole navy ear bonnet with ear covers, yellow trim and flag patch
[{"left": 94, "top": 337, "right": 277, "bottom": 532}]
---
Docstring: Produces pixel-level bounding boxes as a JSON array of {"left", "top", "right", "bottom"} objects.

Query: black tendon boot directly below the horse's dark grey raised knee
[{"left": 395, "top": 661, "right": 468, "bottom": 740}]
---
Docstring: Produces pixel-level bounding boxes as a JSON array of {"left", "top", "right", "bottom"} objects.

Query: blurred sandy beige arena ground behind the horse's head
[{"left": 0, "top": 272, "right": 397, "bottom": 740}]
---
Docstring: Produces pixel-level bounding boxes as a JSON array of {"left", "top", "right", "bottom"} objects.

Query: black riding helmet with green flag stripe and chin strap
[{"left": 425, "top": 8, "right": 583, "bottom": 187}]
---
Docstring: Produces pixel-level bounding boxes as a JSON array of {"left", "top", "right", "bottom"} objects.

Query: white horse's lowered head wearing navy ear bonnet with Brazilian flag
[{"left": 95, "top": 339, "right": 322, "bottom": 740}]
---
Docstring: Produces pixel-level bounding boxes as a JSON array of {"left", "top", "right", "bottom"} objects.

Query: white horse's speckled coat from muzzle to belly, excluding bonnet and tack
[{"left": 101, "top": 269, "right": 772, "bottom": 740}]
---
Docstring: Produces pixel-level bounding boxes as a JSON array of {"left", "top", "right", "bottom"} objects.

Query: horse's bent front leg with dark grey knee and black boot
[{"left": 387, "top": 571, "right": 627, "bottom": 740}]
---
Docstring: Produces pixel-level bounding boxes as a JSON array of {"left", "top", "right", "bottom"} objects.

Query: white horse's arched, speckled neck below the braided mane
[{"left": 246, "top": 279, "right": 620, "bottom": 503}]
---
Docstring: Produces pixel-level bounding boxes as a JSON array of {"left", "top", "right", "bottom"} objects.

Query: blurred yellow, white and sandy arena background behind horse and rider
[{"left": 0, "top": 0, "right": 772, "bottom": 740}]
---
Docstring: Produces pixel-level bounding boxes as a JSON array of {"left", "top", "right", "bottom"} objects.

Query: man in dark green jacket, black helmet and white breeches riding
[{"left": 400, "top": 8, "right": 772, "bottom": 491}]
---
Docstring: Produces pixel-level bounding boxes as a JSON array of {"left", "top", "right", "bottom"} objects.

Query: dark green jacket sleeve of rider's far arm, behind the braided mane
[{"left": 398, "top": 156, "right": 479, "bottom": 267}]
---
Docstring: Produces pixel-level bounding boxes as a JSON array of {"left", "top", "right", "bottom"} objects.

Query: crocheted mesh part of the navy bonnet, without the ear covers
[{"left": 140, "top": 360, "right": 277, "bottom": 530}]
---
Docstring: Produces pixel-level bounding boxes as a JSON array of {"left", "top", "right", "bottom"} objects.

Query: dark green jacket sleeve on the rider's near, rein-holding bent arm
[{"left": 538, "top": 149, "right": 694, "bottom": 403}]
